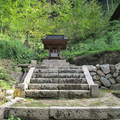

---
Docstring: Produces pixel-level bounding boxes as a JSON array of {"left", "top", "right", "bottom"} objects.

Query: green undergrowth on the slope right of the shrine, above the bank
[{"left": 62, "top": 21, "right": 120, "bottom": 61}]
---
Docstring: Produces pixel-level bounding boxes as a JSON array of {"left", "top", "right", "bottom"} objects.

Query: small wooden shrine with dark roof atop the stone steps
[{"left": 41, "top": 35, "right": 68, "bottom": 59}]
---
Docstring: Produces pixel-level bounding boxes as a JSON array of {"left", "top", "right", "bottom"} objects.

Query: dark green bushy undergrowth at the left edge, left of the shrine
[{"left": 0, "top": 34, "right": 36, "bottom": 63}]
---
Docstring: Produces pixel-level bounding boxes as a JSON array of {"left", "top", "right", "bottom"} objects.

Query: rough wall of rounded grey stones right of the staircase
[{"left": 88, "top": 63, "right": 120, "bottom": 90}]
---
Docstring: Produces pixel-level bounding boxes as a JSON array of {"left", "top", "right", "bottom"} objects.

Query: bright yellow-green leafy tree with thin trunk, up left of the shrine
[{"left": 11, "top": 0, "right": 49, "bottom": 42}]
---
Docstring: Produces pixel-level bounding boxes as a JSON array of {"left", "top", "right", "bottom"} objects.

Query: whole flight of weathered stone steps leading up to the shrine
[{"left": 17, "top": 60, "right": 98, "bottom": 98}]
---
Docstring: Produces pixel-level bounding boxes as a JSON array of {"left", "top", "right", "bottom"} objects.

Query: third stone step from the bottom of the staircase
[{"left": 30, "top": 78, "right": 87, "bottom": 84}]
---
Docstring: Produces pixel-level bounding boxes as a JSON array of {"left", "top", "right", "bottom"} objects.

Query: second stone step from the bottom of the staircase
[{"left": 28, "top": 83, "right": 89, "bottom": 90}]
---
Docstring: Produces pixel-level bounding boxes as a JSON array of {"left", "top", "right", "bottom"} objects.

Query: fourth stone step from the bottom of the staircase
[{"left": 32, "top": 73, "right": 85, "bottom": 78}]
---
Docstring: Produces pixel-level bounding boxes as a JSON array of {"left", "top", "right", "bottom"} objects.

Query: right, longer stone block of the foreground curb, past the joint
[{"left": 50, "top": 107, "right": 120, "bottom": 120}]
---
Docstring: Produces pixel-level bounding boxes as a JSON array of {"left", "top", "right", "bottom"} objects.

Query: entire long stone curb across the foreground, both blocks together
[{"left": 1, "top": 107, "right": 120, "bottom": 120}]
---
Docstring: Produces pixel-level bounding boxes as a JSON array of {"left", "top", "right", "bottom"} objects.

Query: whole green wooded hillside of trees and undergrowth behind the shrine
[{"left": 0, "top": 0, "right": 120, "bottom": 63}]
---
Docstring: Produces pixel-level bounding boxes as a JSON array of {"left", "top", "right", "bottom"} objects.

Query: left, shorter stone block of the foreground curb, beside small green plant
[{"left": 4, "top": 107, "right": 49, "bottom": 120}]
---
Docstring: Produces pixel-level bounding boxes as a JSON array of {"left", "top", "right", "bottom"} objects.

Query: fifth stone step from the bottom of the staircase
[{"left": 34, "top": 69, "right": 83, "bottom": 73}]
